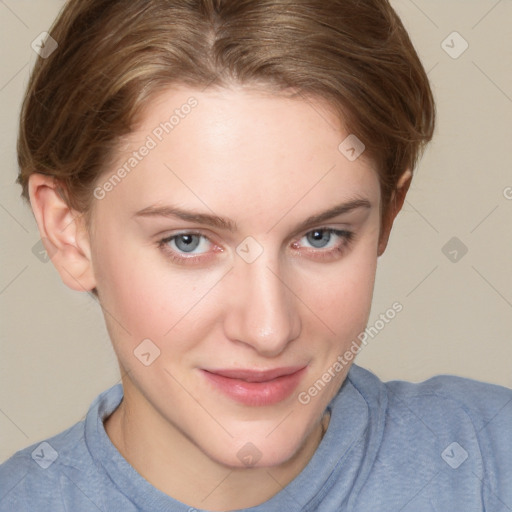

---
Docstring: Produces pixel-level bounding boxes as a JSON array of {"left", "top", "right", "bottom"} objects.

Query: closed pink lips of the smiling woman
[{"left": 201, "top": 366, "right": 307, "bottom": 406}]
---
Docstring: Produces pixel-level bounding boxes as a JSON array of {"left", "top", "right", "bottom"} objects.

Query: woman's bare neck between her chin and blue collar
[{"left": 104, "top": 384, "right": 330, "bottom": 511}]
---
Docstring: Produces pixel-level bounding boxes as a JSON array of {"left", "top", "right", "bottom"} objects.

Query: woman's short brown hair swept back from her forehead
[{"left": 18, "top": 0, "right": 435, "bottom": 224}]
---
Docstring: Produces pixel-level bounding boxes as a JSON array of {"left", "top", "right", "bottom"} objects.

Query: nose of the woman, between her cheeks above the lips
[{"left": 225, "top": 251, "right": 301, "bottom": 357}]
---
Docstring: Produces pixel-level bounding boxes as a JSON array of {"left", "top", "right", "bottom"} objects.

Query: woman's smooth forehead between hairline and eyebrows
[{"left": 96, "top": 86, "right": 378, "bottom": 224}]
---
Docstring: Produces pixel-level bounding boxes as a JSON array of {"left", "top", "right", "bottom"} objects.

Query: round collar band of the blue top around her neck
[{"left": 84, "top": 365, "right": 383, "bottom": 512}]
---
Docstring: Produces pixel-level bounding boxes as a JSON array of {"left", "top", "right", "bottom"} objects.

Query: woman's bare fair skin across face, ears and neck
[{"left": 30, "top": 86, "right": 411, "bottom": 510}]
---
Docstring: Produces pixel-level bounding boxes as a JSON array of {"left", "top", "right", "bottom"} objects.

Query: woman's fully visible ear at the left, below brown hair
[{"left": 28, "top": 173, "right": 96, "bottom": 291}]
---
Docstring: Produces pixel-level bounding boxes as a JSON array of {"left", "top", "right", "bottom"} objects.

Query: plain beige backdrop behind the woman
[{"left": 0, "top": 0, "right": 512, "bottom": 461}]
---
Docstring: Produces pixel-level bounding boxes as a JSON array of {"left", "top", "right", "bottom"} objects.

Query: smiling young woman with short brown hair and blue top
[{"left": 0, "top": 0, "right": 512, "bottom": 512}]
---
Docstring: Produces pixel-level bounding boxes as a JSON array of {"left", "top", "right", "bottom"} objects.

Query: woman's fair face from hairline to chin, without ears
[{"left": 90, "top": 83, "right": 380, "bottom": 467}]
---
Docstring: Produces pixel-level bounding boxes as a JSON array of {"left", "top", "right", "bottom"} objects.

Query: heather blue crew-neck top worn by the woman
[{"left": 0, "top": 366, "right": 512, "bottom": 512}]
